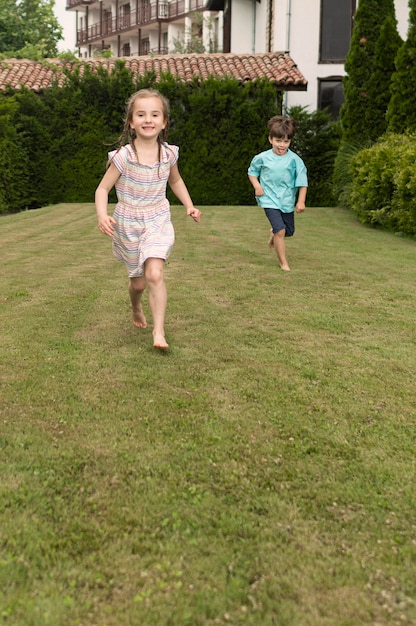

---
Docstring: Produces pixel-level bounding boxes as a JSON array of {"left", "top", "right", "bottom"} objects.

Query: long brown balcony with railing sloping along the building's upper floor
[{"left": 75, "top": 0, "right": 205, "bottom": 46}]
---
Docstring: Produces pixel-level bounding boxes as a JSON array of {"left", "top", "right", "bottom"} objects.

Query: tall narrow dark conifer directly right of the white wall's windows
[{"left": 340, "top": 0, "right": 400, "bottom": 145}]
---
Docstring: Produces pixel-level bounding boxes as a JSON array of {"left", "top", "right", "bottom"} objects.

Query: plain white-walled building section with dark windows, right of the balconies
[{"left": 224, "top": 0, "right": 409, "bottom": 113}]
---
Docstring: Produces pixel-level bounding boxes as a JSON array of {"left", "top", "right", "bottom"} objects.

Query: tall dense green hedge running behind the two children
[{"left": 0, "top": 60, "right": 337, "bottom": 212}]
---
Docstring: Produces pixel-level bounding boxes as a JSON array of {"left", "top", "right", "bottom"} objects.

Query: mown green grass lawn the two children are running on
[{"left": 0, "top": 204, "right": 416, "bottom": 626}]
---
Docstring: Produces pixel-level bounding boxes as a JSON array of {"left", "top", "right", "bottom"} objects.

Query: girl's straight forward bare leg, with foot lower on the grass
[{"left": 144, "top": 258, "right": 169, "bottom": 350}]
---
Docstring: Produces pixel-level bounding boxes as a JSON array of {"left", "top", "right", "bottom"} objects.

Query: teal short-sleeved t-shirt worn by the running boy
[{"left": 247, "top": 149, "right": 308, "bottom": 213}]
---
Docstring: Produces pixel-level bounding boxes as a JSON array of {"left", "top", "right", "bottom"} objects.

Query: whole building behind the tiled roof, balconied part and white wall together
[{"left": 67, "top": 0, "right": 409, "bottom": 117}]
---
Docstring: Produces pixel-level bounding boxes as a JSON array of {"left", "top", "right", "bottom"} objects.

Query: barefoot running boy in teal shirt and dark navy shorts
[{"left": 248, "top": 115, "right": 308, "bottom": 272}]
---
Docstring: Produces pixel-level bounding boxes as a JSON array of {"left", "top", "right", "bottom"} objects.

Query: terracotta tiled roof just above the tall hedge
[{"left": 0, "top": 52, "right": 307, "bottom": 92}]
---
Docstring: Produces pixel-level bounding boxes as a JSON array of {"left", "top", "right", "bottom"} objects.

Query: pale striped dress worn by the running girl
[{"left": 108, "top": 143, "right": 179, "bottom": 278}]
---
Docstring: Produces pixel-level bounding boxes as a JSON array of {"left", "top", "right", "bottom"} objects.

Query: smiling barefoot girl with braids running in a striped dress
[{"left": 95, "top": 89, "right": 201, "bottom": 350}]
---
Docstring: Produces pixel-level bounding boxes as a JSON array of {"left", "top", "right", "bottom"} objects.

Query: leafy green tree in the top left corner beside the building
[{"left": 0, "top": 0, "right": 62, "bottom": 60}]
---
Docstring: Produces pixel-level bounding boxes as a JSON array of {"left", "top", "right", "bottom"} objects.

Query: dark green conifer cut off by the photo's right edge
[{"left": 387, "top": 0, "right": 416, "bottom": 133}]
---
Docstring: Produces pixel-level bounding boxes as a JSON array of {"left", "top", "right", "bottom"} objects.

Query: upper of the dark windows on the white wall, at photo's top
[{"left": 320, "top": 0, "right": 355, "bottom": 63}]
